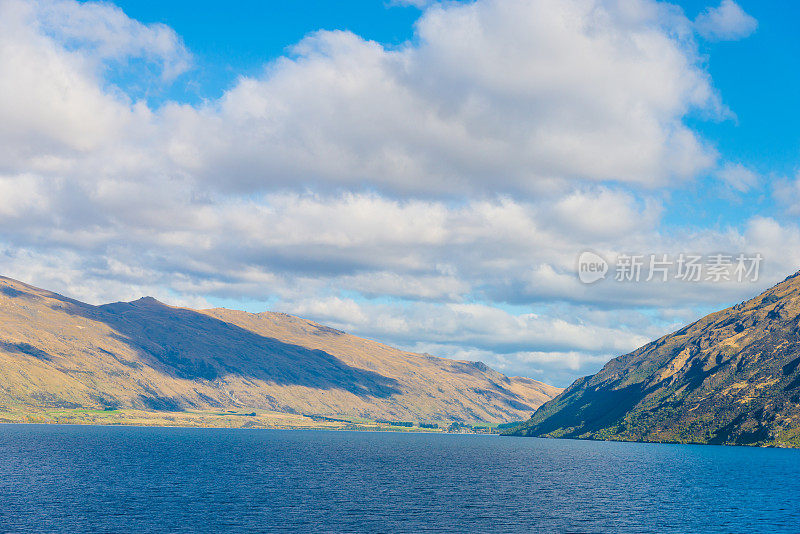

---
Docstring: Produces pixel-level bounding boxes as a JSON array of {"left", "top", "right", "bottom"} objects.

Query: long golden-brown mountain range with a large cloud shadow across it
[{"left": 0, "top": 277, "right": 561, "bottom": 430}]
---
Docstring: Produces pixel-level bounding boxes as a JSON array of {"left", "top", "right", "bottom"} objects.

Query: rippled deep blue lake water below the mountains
[{"left": 0, "top": 425, "right": 800, "bottom": 533}]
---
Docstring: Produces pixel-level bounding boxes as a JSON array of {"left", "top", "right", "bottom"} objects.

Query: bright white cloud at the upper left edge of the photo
[{"left": 0, "top": 1, "right": 127, "bottom": 160}]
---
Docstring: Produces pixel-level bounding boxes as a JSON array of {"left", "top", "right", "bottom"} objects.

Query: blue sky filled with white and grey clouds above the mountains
[{"left": 0, "top": 0, "right": 800, "bottom": 386}]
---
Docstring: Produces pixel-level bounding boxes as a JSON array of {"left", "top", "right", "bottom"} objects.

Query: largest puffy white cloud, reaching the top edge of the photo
[{"left": 183, "top": 0, "right": 719, "bottom": 195}]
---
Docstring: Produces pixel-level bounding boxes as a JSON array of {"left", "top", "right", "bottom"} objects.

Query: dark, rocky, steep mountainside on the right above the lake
[{"left": 509, "top": 273, "right": 800, "bottom": 447}]
